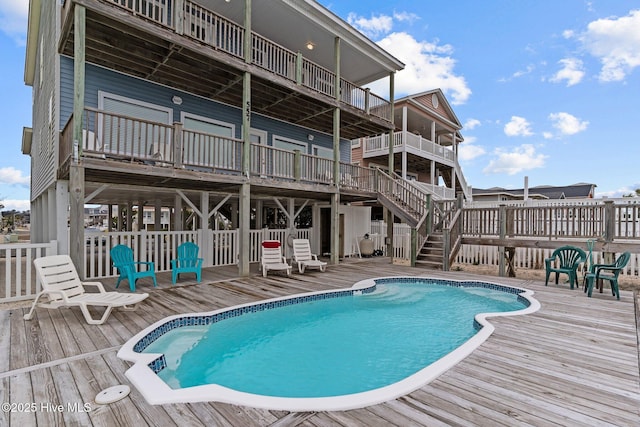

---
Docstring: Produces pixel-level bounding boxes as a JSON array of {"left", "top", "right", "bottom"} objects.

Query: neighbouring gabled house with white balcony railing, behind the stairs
[{"left": 351, "top": 89, "right": 471, "bottom": 199}]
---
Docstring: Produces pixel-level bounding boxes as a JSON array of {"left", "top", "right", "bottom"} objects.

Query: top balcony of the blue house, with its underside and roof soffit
[{"left": 59, "top": 0, "right": 402, "bottom": 138}]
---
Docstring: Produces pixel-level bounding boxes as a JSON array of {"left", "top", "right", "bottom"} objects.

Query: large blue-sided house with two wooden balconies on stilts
[{"left": 22, "top": 0, "right": 404, "bottom": 274}]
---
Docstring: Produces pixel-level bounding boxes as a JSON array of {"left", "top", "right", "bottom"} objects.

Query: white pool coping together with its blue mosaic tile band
[{"left": 117, "top": 276, "right": 540, "bottom": 412}]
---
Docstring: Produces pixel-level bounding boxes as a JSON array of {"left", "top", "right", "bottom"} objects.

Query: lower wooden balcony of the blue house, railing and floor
[{"left": 58, "top": 107, "right": 379, "bottom": 200}]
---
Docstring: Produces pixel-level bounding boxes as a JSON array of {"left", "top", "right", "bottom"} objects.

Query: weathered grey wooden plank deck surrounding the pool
[{"left": 0, "top": 259, "right": 640, "bottom": 427}]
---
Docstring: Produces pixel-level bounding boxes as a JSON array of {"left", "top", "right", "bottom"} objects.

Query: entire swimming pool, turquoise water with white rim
[{"left": 118, "top": 277, "right": 539, "bottom": 411}]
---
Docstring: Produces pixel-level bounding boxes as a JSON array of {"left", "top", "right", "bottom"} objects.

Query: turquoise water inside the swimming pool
[{"left": 144, "top": 280, "right": 526, "bottom": 398}]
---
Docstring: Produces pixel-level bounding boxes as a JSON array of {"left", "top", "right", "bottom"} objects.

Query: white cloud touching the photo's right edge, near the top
[{"left": 578, "top": 10, "right": 640, "bottom": 82}]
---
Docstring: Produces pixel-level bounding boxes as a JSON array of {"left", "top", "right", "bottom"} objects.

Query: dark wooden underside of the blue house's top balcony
[{"left": 60, "top": 2, "right": 390, "bottom": 139}]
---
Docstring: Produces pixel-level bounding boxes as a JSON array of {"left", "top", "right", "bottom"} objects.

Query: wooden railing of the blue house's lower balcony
[{"left": 59, "top": 107, "right": 384, "bottom": 192}]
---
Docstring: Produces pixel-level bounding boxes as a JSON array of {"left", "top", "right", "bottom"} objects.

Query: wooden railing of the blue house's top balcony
[{"left": 98, "top": 0, "right": 391, "bottom": 121}]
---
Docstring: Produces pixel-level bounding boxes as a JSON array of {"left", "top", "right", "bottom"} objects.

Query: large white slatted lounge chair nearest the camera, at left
[{"left": 24, "top": 255, "right": 149, "bottom": 325}]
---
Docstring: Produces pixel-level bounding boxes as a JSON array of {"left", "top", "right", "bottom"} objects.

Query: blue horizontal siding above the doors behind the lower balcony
[{"left": 60, "top": 56, "right": 351, "bottom": 162}]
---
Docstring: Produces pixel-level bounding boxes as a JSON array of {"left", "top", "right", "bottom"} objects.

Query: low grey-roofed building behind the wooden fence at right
[{"left": 473, "top": 182, "right": 596, "bottom": 202}]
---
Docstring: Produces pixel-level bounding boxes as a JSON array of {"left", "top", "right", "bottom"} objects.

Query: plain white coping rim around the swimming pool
[{"left": 117, "top": 276, "right": 540, "bottom": 412}]
